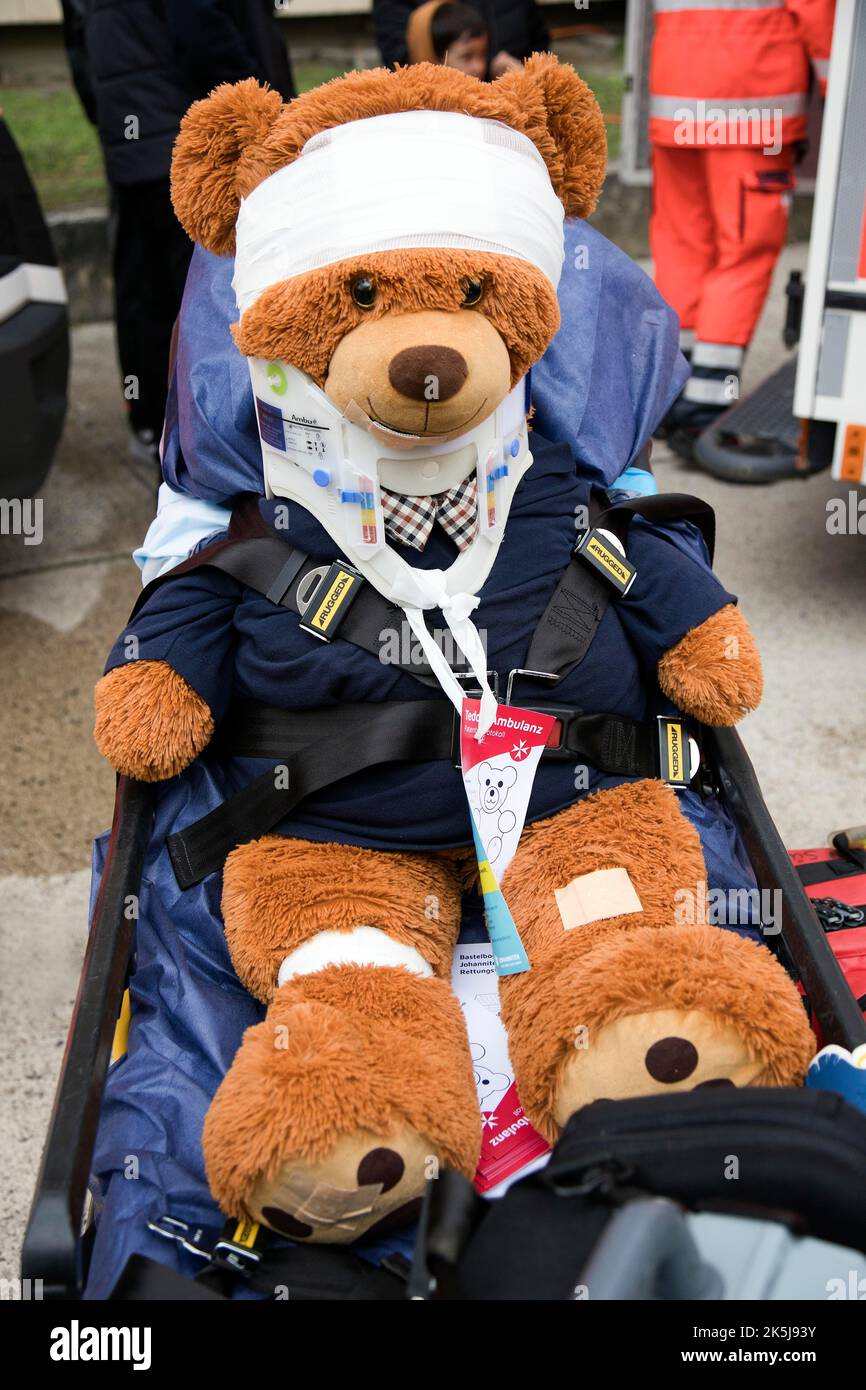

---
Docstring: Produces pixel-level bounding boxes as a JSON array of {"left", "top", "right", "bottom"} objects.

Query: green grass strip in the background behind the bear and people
[{"left": 0, "top": 63, "right": 623, "bottom": 213}]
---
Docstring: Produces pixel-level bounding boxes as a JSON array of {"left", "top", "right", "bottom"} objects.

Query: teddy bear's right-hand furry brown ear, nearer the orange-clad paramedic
[{"left": 492, "top": 53, "right": 607, "bottom": 217}]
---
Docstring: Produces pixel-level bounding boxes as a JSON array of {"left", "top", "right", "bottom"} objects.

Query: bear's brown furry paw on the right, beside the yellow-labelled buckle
[{"left": 657, "top": 603, "right": 763, "bottom": 727}]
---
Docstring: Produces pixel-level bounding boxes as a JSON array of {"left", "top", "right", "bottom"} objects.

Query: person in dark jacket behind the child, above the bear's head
[{"left": 373, "top": 0, "right": 550, "bottom": 78}]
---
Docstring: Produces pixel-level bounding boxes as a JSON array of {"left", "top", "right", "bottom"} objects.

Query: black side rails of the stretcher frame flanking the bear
[{"left": 21, "top": 728, "right": 866, "bottom": 1300}]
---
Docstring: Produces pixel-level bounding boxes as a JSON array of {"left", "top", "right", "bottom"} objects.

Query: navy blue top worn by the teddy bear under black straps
[{"left": 107, "top": 432, "right": 734, "bottom": 849}]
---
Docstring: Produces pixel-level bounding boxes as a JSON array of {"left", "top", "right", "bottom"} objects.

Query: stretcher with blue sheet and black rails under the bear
[{"left": 24, "top": 201, "right": 866, "bottom": 1300}]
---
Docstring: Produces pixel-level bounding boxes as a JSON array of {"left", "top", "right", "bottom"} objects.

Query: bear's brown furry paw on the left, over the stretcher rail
[{"left": 93, "top": 660, "right": 214, "bottom": 781}]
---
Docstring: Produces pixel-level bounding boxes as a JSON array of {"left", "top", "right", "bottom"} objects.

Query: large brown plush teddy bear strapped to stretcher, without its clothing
[{"left": 96, "top": 56, "right": 812, "bottom": 1241}]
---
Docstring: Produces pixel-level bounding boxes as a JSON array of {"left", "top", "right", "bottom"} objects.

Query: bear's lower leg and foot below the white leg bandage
[{"left": 203, "top": 966, "right": 481, "bottom": 1244}]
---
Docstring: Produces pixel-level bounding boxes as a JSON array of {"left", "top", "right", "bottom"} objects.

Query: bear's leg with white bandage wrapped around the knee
[{"left": 203, "top": 837, "right": 481, "bottom": 1243}]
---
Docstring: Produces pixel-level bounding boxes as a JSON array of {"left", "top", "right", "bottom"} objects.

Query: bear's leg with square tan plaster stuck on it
[{"left": 502, "top": 781, "right": 815, "bottom": 1140}]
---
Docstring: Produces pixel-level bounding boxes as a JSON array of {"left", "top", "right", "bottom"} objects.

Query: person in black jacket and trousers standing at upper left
[{"left": 76, "top": 0, "right": 295, "bottom": 472}]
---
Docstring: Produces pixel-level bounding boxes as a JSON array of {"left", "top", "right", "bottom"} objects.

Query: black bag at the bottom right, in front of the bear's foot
[{"left": 411, "top": 1087, "right": 866, "bottom": 1300}]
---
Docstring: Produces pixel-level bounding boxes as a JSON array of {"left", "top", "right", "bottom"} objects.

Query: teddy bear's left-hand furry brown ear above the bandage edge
[{"left": 171, "top": 78, "right": 285, "bottom": 256}]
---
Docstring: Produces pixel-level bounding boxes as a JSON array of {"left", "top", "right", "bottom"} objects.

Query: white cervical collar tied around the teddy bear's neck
[{"left": 249, "top": 357, "right": 532, "bottom": 738}]
